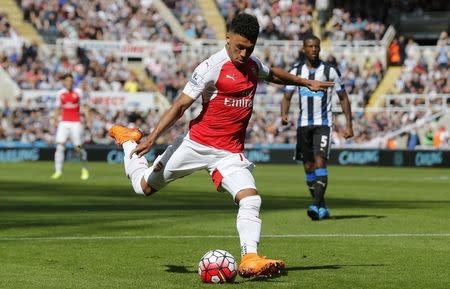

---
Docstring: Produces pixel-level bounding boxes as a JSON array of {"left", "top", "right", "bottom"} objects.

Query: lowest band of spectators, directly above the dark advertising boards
[{"left": 0, "top": 97, "right": 450, "bottom": 148}]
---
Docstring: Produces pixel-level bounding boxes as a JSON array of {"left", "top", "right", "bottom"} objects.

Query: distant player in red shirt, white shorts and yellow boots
[{"left": 51, "top": 74, "right": 90, "bottom": 180}]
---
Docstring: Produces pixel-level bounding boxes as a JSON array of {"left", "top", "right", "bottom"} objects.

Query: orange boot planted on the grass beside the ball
[{"left": 238, "top": 253, "right": 285, "bottom": 278}]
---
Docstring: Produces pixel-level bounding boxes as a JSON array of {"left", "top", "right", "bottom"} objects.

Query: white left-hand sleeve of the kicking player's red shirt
[{"left": 183, "top": 60, "right": 217, "bottom": 99}]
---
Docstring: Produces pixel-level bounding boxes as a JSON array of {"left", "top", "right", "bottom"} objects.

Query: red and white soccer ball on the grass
[{"left": 198, "top": 250, "right": 237, "bottom": 283}]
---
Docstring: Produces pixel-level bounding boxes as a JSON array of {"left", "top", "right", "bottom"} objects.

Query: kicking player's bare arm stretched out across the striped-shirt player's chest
[{"left": 266, "top": 67, "right": 334, "bottom": 90}]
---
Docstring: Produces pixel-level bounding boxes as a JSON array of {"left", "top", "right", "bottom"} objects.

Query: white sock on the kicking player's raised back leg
[{"left": 122, "top": 141, "right": 148, "bottom": 195}]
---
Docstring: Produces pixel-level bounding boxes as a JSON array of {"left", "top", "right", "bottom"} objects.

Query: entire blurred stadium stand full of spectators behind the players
[{"left": 0, "top": 0, "right": 450, "bottom": 150}]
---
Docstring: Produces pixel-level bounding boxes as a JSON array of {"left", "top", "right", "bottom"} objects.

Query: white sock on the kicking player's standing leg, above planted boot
[{"left": 236, "top": 195, "right": 261, "bottom": 256}]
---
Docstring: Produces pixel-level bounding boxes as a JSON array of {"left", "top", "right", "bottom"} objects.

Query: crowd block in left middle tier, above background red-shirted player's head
[{"left": 0, "top": 43, "right": 143, "bottom": 91}]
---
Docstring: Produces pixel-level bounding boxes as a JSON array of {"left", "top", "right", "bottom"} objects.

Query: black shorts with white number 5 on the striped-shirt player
[{"left": 295, "top": 125, "right": 331, "bottom": 162}]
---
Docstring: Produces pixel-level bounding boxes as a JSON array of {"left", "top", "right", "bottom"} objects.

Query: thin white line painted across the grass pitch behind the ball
[{"left": 0, "top": 233, "right": 450, "bottom": 241}]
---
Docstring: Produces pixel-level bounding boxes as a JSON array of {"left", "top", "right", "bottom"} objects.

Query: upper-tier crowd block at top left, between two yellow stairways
[{"left": 17, "top": 0, "right": 173, "bottom": 43}]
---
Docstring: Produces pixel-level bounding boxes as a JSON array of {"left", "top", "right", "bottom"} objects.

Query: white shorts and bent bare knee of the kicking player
[{"left": 147, "top": 135, "right": 256, "bottom": 199}]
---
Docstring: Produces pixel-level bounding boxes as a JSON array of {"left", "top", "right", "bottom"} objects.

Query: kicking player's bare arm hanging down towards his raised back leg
[{"left": 130, "top": 93, "right": 195, "bottom": 158}]
